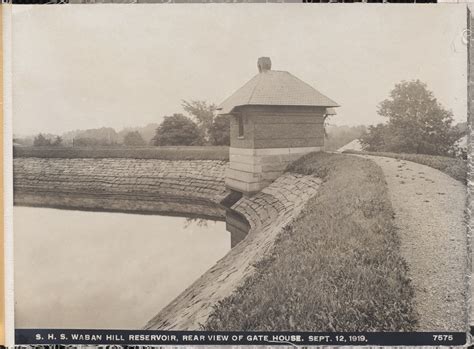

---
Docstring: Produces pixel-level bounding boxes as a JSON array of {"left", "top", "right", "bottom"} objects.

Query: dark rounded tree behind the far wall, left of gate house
[{"left": 153, "top": 114, "right": 203, "bottom": 145}]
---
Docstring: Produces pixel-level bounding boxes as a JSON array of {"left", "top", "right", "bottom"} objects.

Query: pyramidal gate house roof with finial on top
[{"left": 218, "top": 57, "right": 339, "bottom": 114}]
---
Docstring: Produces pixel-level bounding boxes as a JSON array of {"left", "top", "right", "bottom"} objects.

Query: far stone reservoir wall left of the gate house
[{"left": 13, "top": 158, "right": 227, "bottom": 219}]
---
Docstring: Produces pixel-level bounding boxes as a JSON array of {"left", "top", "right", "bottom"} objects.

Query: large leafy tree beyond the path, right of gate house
[{"left": 361, "top": 80, "right": 460, "bottom": 155}]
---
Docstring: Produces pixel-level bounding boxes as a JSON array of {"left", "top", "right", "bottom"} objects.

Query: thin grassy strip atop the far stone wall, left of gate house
[{"left": 13, "top": 146, "right": 229, "bottom": 161}]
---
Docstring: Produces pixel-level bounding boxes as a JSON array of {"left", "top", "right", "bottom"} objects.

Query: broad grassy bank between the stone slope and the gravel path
[{"left": 203, "top": 153, "right": 417, "bottom": 331}]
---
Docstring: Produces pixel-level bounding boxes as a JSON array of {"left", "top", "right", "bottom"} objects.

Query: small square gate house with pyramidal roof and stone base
[{"left": 218, "top": 57, "right": 339, "bottom": 195}]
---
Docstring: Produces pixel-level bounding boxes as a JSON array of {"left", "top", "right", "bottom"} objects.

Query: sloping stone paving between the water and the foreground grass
[{"left": 144, "top": 173, "right": 321, "bottom": 330}]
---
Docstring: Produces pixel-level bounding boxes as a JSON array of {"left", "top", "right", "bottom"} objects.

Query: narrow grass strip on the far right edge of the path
[{"left": 344, "top": 150, "right": 467, "bottom": 184}]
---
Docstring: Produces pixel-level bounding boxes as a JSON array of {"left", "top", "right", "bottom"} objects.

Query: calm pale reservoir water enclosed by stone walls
[{"left": 14, "top": 207, "right": 231, "bottom": 329}]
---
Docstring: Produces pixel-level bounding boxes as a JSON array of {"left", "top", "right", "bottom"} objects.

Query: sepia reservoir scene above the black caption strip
[{"left": 11, "top": 4, "right": 470, "bottom": 332}]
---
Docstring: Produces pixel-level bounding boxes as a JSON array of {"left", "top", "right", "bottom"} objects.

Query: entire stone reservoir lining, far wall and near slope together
[{"left": 14, "top": 158, "right": 321, "bottom": 330}]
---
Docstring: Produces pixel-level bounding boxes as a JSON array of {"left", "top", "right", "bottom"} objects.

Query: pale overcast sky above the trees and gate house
[{"left": 13, "top": 4, "right": 467, "bottom": 135}]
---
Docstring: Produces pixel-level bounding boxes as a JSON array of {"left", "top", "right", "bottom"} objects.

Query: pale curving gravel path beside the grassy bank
[{"left": 358, "top": 156, "right": 467, "bottom": 331}]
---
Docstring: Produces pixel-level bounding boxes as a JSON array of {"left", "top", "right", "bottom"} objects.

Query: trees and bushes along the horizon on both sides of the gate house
[{"left": 26, "top": 80, "right": 467, "bottom": 157}]
